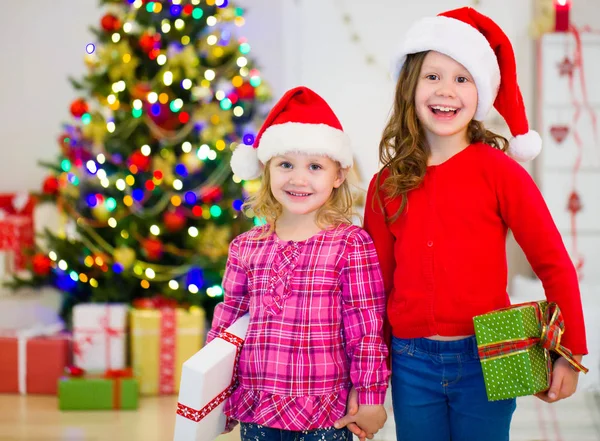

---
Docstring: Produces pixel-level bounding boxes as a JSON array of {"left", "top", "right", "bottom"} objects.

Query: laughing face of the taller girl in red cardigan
[{"left": 415, "top": 51, "right": 477, "bottom": 145}]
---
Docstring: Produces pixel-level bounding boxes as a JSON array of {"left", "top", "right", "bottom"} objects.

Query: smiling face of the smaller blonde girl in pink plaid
[{"left": 269, "top": 153, "right": 345, "bottom": 220}]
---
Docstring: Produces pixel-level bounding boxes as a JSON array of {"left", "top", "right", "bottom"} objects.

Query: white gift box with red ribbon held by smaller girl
[{"left": 173, "top": 314, "right": 249, "bottom": 441}]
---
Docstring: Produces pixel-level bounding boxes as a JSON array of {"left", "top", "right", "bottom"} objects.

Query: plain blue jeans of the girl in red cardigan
[{"left": 392, "top": 337, "right": 516, "bottom": 441}]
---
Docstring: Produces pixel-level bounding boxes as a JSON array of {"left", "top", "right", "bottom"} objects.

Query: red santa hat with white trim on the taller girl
[{"left": 394, "top": 7, "right": 542, "bottom": 161}]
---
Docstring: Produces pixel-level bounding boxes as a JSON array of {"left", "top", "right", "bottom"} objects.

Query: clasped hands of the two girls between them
[{"left": 335, "top": 388, "right": 387, "bottom": 441}]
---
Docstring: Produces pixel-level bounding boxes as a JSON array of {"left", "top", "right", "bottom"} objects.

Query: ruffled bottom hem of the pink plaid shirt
[{"left": 224, "top": 386, "right": 349, "bottom": 431}]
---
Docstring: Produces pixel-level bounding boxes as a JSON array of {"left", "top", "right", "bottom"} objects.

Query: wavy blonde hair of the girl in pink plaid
[{"left": 244, "top": 160, "right": 355, "bottom": 239}]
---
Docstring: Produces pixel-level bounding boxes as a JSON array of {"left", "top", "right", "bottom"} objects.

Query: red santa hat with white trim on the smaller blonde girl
[{"left": 231, "top": 87, "right": 353, "bottom": 180}]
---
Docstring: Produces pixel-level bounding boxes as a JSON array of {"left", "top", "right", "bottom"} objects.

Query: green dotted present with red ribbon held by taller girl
[{"left": 473, "top": 301, "right": 587, "bottom": 401}]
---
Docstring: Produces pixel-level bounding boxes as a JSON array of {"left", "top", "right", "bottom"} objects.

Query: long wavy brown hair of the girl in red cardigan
[{"left": 376, "top": 51, "right": 508, "bottom": 222}]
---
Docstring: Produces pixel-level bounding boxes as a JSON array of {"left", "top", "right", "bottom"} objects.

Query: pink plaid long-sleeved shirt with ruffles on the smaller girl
[{"left": 207, "top": 225, "right": 389, "bottom": 430}]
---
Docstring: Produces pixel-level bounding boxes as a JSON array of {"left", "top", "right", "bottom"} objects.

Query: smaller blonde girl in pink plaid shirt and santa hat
[{"left": 207, "top": 87, "right": 389, "bottom": 441}]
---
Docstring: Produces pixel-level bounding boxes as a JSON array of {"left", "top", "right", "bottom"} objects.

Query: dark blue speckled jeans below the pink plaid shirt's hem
[{"left": 240, "top": 423, "right": 352, "bottom": 441}]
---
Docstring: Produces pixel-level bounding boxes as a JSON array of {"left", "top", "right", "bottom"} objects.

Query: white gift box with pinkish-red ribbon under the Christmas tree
[{"left": 73, "top": 303, "right": 129, "bottom": 371}]
